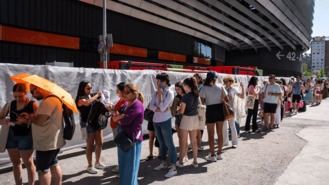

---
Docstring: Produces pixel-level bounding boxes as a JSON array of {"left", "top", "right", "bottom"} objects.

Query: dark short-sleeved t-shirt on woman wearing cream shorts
[{"left": 182, "top": 93, "right": 199, "bottom": 116}]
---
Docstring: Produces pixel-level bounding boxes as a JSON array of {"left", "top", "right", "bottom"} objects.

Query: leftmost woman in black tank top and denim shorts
[{"left": 0, "top": 83, "right": 37, "bottom": 185}]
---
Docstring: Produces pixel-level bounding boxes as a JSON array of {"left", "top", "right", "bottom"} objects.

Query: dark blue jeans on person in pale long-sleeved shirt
[{"left": 154, "top": 119, "right": 177, "bottom": 164}]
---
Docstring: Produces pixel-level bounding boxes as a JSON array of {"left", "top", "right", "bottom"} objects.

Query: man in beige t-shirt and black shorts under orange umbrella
[{"left": 23, "top": 85, "right": 65, "bottom": 185}]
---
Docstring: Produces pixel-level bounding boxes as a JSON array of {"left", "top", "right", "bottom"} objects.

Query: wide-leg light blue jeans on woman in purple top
[{"left": 118, "top": 141, "right": 142, "bottom": 185}]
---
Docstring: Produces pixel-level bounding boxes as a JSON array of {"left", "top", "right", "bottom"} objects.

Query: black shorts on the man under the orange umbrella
[{"left": 35, "top": 149, "right": 59, "bottom": 172}]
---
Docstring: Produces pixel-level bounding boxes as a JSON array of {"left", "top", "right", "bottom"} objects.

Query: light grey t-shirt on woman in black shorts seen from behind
[{"left": 200, "top": 85, "right": 227, "bottom": 105}]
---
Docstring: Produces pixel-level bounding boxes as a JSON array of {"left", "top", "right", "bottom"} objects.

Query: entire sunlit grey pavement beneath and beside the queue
[{"left": 0, "top": 100, "right": 329, "bottom": 185}]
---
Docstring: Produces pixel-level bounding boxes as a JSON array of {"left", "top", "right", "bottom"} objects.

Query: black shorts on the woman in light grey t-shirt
[{"left": 206, "top": 103, "right": 224, "bottom": 124}]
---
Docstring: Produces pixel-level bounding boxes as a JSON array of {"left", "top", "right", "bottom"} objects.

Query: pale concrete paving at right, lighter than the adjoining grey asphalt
[{"left": 276, "top": 100, "right": 329, "bottom": 185}]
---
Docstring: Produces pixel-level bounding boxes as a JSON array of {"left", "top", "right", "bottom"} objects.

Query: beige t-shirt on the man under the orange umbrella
[{"left": 32, "top": 97, "right": 65, "bottom": 151}]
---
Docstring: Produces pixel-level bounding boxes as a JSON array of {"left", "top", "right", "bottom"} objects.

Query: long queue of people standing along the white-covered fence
[{"left": 0, "top": 72, "right": 329, "bottom": 185}]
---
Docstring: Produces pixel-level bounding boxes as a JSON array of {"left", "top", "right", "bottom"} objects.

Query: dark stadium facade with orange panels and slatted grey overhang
[{"left": 0, "top": 0, "right": 314, "bottom": 75}]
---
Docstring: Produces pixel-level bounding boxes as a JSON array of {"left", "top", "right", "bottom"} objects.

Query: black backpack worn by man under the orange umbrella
[{"left": 47, "top": 95, "right": 75, "bottom": 140}]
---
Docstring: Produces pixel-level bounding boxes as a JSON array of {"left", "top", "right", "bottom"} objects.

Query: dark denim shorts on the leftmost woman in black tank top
[{"left": 6, "top": 128, "right": 33, "bottom": 150}]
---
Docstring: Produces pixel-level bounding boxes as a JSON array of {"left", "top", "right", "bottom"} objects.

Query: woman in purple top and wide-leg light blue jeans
[{"left": 113, "top": 84, "right": 144, "bottom": 185}]
